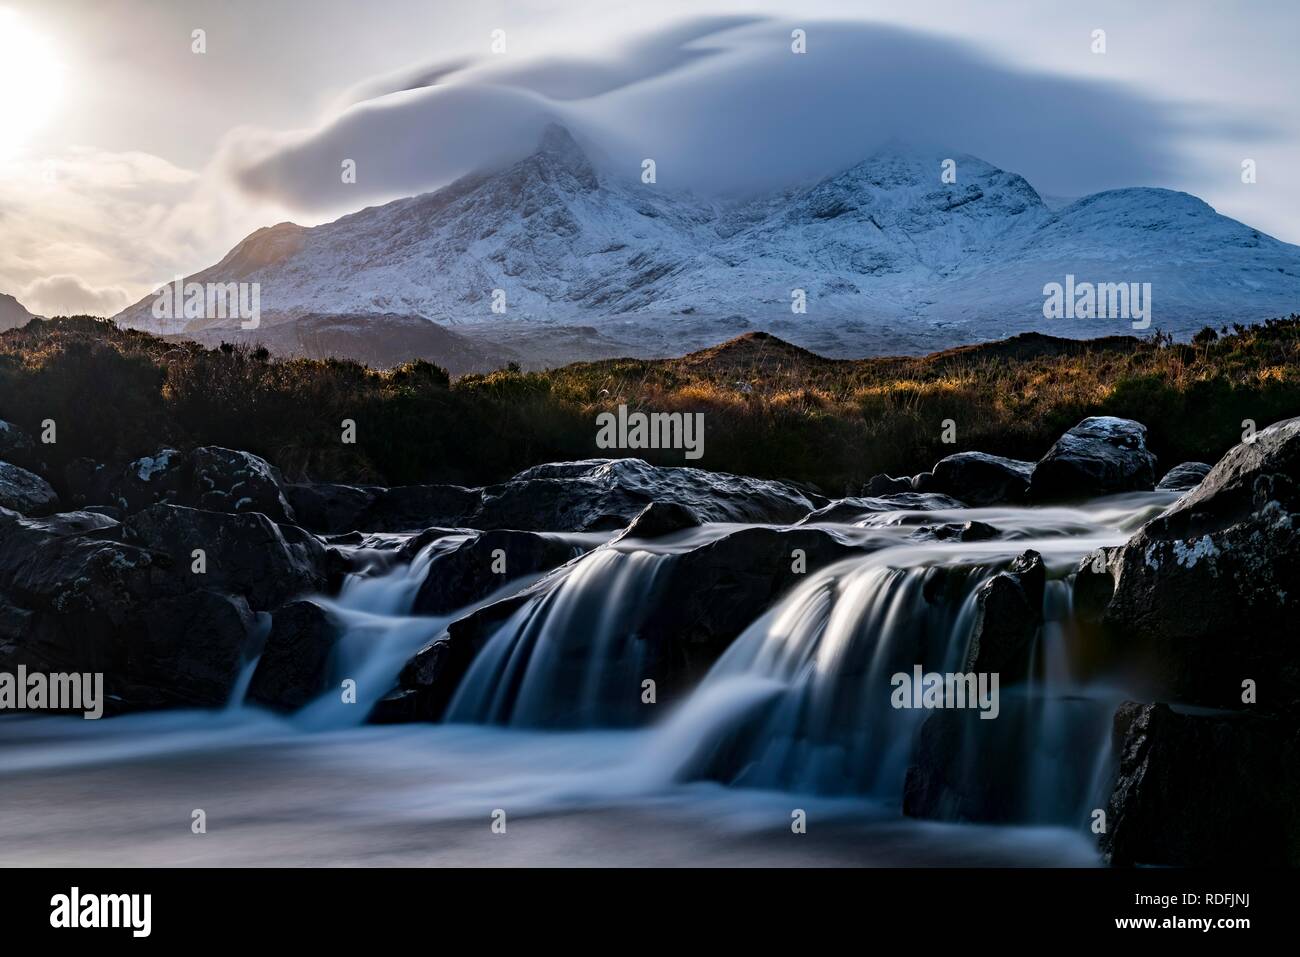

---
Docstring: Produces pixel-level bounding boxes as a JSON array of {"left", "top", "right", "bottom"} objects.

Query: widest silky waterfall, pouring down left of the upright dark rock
[{"left": 634, "top": 553, "right": 992, "bottom": 794}]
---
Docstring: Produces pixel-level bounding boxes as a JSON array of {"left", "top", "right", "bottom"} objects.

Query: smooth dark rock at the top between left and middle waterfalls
[{"left": 413, "top": 531, "right": 581, "bottom": 615}]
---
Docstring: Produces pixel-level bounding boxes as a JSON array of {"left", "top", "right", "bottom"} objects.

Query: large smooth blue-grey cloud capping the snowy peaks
[{"left": 221, "top": 18, "right": 1242, "bottom": 213}]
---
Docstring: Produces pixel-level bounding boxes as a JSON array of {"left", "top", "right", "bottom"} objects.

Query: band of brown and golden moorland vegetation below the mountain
[{"left": 0, "top": 316, "right": 1300, "bottom": 494}]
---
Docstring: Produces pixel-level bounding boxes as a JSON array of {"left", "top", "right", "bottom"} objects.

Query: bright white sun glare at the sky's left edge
[{"left": 0, "top": 8, "right": 62, "bottom": 157}]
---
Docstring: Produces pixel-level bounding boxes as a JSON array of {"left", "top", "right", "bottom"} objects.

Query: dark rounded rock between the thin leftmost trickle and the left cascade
[{"left": 248, "top": 601, "right": 339, "bottom": 711}]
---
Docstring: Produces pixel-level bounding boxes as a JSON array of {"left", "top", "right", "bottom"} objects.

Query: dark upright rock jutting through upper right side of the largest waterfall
[{"left": 962, "top": 549, "right": 1047, "bottom": 688}]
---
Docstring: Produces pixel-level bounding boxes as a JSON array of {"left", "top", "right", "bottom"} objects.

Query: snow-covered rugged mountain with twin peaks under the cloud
[{"left": 117, "top": 126, "right": 1300, "bottom": 360}]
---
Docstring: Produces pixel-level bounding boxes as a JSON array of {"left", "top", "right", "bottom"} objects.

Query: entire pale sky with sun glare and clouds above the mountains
[{"left": 0, "top": 0, "right": 1300, "bottom": 315}]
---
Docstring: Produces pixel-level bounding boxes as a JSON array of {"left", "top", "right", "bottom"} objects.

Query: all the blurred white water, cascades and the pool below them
[{"left": 0, "top": 494, "right": 1173, "bottom": 865}]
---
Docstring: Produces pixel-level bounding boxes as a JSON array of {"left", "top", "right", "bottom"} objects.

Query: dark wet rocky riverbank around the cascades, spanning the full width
[{"left": 0, "top": 416, "right": 1300, "bottom": 865}]
